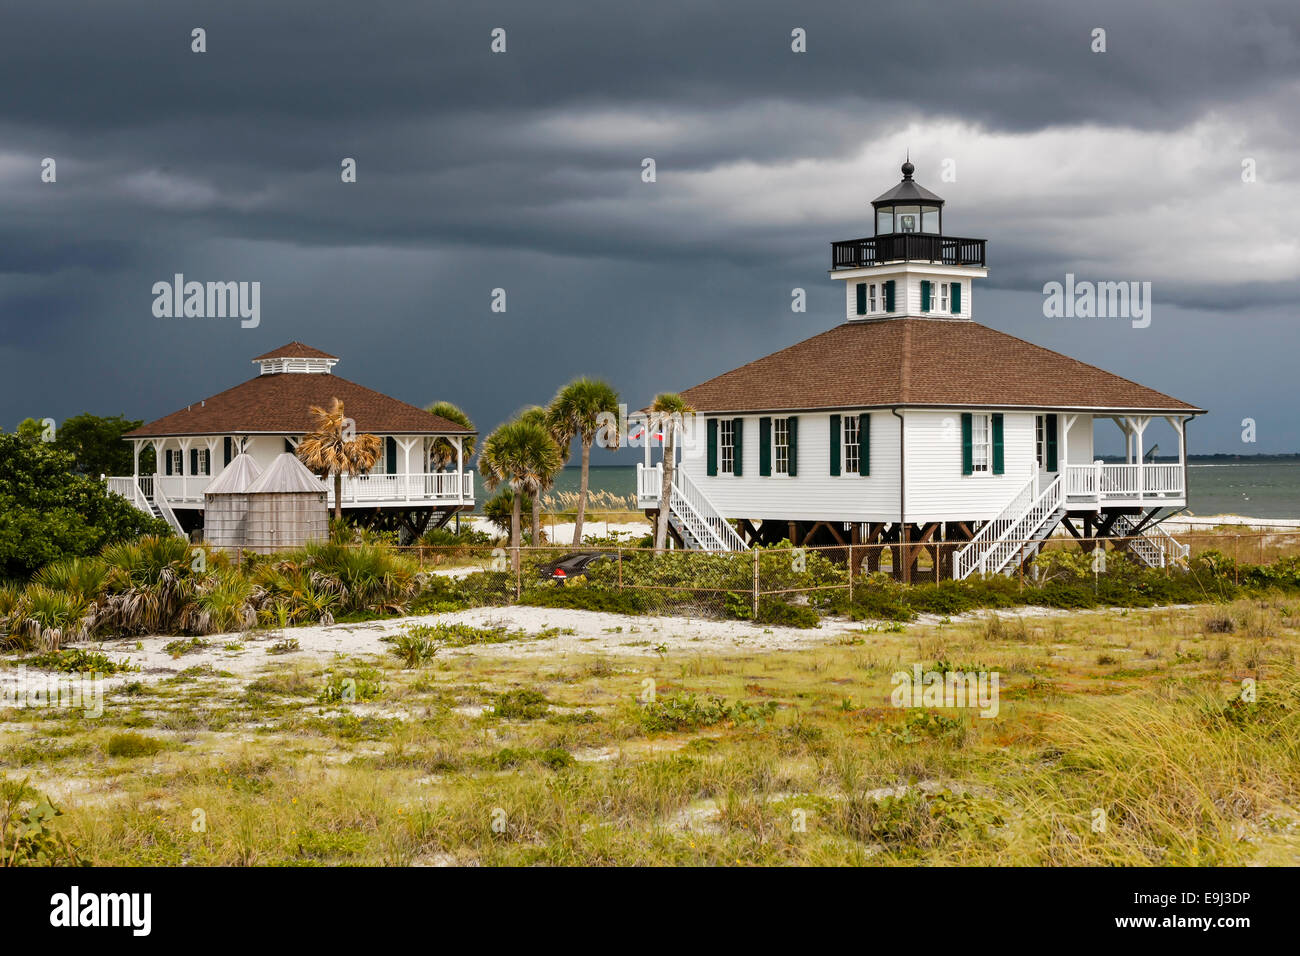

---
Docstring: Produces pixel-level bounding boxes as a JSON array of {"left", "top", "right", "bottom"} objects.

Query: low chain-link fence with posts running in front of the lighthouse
[{"left": 379, "top": 531, "right": 1300, "bottom": 623}]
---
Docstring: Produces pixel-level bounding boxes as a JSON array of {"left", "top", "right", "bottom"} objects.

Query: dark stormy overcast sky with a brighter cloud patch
[{"left": 0, "top": 0, "right": 1300, "bottom": 453}]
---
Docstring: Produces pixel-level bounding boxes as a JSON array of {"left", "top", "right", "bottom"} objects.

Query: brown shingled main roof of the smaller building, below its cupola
[{"left": 124, "top": 371, "right": 473, "bottom": 438}]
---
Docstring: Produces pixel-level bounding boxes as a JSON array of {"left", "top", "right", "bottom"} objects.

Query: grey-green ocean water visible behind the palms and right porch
[{"left": 533, "top": 462, "right": 1300, "bottom": 518}]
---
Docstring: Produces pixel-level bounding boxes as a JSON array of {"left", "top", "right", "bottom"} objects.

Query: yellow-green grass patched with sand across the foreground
[{"left": 0, "top": 594, "right": 1300, "bottom": 865}]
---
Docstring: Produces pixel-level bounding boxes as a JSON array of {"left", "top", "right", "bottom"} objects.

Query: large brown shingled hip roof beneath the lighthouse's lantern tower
[{"left": 683, "top": 319, "right": 1204, "bottom": 414}]
